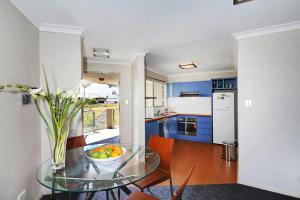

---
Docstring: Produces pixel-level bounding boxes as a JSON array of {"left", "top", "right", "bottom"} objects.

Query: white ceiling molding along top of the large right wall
[{"left": 232, "top": 21, "right": 300, "bottom": 40}]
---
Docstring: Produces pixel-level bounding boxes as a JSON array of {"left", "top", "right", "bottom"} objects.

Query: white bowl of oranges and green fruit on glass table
[{"left": 87, "top": 145, "right": 126, "bottom": 162}]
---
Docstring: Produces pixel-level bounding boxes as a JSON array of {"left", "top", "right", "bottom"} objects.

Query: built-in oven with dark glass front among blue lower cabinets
[{"left": 177, "top": 117, "right": 197, "bottom": 136}]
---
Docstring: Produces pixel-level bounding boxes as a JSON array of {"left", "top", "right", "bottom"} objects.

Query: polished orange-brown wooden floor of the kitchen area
[{"left": 161, "top": 140, "right": 237, "bottom": 185}]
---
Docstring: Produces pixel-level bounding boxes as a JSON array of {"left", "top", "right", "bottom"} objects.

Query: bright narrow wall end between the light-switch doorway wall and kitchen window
[{"left": 132, "top": 55, "right": 145, "bottom": 145}]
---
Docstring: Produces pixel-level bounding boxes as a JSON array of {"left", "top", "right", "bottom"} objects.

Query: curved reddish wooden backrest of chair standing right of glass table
[{"left": 148, "top": 134, "right": 174, "bottom": 174}]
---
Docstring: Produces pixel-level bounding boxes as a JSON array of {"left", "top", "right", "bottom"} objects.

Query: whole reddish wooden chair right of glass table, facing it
[{"left": 134, "top": 135, "right": 174, "bottom": 194}]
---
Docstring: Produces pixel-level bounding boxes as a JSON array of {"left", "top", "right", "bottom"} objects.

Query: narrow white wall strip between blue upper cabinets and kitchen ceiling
[{"left": 167, "top": 69, "right": 237, "bottom": 83}]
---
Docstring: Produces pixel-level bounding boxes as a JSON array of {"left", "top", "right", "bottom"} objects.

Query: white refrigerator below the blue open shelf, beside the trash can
[{"left": 213, "top": 92, "right": 236, "bottom": 144}]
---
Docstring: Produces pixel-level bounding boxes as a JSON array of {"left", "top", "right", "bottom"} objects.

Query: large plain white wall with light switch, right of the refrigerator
[{"left": 238, "top": 29, "right": 300, "bottom": 197}]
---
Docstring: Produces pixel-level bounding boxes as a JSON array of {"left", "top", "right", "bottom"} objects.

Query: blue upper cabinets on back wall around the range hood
[{"left": 167, "top": 81, "right": 212, "bottom": 97}]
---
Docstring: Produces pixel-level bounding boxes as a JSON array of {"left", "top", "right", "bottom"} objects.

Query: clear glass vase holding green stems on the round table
[{"left": 48, "top": 131, "right": 68, "bottom": 171}]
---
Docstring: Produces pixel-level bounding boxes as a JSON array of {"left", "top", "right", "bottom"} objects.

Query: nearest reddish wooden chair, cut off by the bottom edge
[{"left": 126, "top": 162, "right": 196, "bottom": 200}]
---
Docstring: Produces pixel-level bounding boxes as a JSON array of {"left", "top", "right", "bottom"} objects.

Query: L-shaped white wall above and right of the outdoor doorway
[{"left": 85, "top": 62, "right": 133, "bottom": 143}]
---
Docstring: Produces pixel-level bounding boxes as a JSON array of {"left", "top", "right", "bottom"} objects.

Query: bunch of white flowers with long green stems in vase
[{"left": 0, "top": 66, "right": 88, "bottom": 167}]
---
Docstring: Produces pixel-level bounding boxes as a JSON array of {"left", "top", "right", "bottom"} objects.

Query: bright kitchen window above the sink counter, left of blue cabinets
[{"left": 146, "top": 79, "right": 166, "bottom": 107}]
